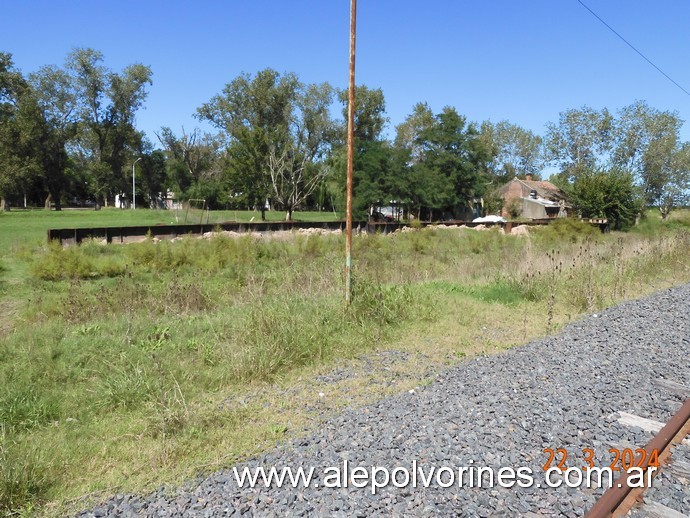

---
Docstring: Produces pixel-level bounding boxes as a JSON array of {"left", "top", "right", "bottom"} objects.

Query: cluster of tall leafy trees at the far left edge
[{"left": 0, "top": 49, "right": 151, "bottom": 210}]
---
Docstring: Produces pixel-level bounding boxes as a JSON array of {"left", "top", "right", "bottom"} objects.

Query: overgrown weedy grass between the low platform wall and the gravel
[{"left": 0, "top": 210, "right": 690, "bottom": 514}]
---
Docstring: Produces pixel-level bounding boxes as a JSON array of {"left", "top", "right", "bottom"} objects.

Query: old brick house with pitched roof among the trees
[{"left": 497, "top": 174, "right": 572, "bottom": 219}]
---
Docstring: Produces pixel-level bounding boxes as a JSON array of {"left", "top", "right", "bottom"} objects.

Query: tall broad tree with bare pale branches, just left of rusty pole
[{"left": 197, "top": 69, "right": 334, "bottom": 219}]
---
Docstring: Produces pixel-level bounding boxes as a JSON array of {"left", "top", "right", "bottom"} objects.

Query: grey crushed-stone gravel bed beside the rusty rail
[{"left": 80, "top": 285, "right": 690, "bottom": 517}]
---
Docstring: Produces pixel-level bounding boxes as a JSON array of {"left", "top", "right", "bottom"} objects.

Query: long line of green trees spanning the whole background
[{"left": 0, "top": 49, "right": 690, "bottom": 226}]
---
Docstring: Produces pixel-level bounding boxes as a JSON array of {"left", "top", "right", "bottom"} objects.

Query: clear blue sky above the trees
[{"left": 5, "top": 0, "right": 690, "bottom": 143}]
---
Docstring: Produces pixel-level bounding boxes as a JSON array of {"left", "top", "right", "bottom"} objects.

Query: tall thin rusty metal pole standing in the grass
[{"left": 345, "top": 0, "right": 357, "bottom": 306}]
